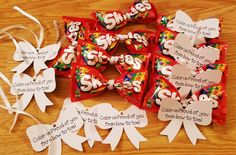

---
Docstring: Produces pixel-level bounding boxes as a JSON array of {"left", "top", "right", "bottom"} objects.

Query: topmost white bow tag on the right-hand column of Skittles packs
[{"left": 172, "top": 10, "right": 220, "bottom": 38}]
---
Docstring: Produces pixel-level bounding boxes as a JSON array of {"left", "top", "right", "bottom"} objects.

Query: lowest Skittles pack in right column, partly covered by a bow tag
[{"left": 142, "top": 77, "right": 227, "bottom": 125}]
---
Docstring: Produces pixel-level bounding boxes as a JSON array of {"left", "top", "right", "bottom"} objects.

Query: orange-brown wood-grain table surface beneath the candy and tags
[{"left": 0, "top": 0, "right": 236, "bottom": 155}]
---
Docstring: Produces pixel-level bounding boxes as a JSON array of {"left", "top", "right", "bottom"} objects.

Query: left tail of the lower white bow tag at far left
[{"left": 12, "top": 93, "right": 34, "bottom": 111}]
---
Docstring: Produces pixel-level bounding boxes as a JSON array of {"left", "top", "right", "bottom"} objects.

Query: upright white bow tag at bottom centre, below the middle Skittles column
[{"left": 98, "top": 106, "right": 148, "bottom": 150}]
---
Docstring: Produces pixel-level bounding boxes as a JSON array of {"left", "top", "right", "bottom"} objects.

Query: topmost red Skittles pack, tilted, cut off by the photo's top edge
[{"left": 92, "top": 0, "right": 157, "bottom": 30}]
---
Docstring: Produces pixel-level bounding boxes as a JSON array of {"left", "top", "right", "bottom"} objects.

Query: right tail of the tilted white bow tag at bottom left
[{"left": 62, "top": 133, "right": 87, "bottom": 151}]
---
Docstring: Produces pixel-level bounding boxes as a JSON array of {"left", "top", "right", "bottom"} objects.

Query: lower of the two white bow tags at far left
[{"left": 11, "top": 68, "right": 56, "bottom": 112}]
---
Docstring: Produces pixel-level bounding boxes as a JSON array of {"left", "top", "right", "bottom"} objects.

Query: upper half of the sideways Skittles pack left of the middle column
[{"left": 63, "top": 16, "right": 97, "bottom": 46}]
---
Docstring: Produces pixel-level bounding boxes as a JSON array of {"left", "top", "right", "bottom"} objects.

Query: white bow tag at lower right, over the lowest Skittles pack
[{"left": 158, "top": 98, "right": 213, "bottom": 145}]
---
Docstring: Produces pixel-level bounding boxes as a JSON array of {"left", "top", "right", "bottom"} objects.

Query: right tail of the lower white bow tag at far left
[{"left": 34, "top": 91, "right": 53, "bottom": 113}]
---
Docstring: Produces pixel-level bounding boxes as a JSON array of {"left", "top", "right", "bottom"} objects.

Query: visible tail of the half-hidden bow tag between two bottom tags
[{"left": 84, "top": 122, "right": 102, "bottom": 148}]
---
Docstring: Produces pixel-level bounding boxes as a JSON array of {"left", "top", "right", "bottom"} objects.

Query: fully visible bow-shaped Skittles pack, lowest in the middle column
[{"left": 71, "top": 63, "right": 147, "bottom": 107}]
